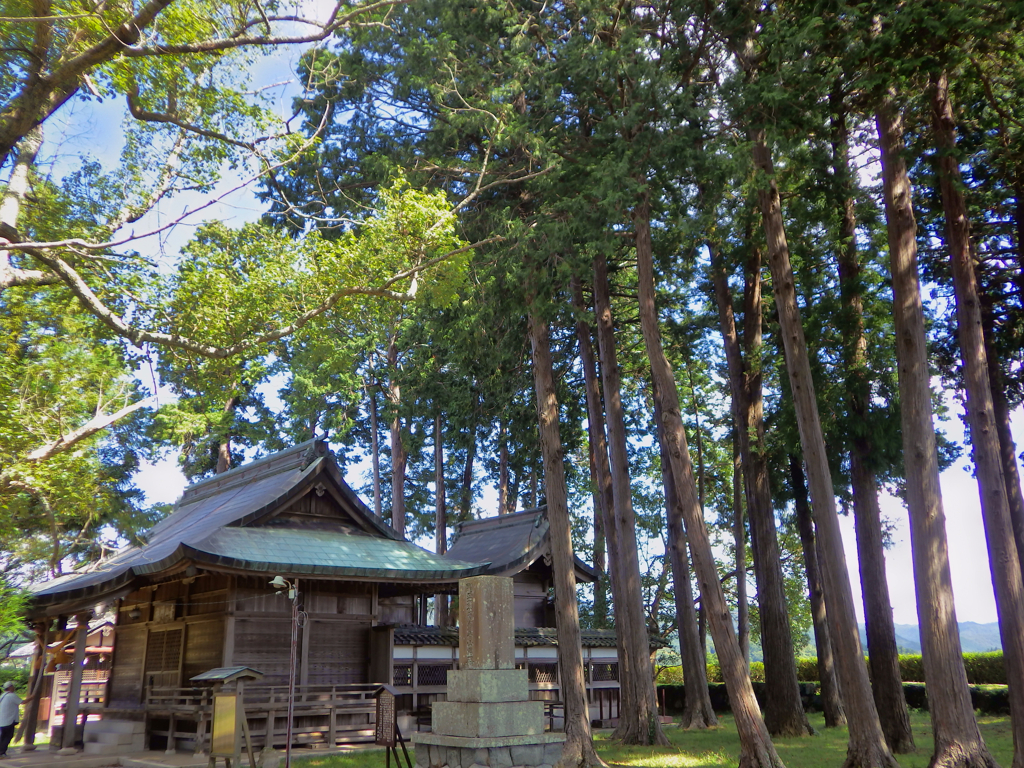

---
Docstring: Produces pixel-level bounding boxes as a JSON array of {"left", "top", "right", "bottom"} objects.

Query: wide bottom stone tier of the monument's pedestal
[{"left": 413, "top": 733, "right": 565, "bottom": 768}]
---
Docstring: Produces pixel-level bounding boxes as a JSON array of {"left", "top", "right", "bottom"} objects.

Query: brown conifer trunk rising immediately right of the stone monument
[{"left": 528, "top": 312, "right": 603, "bottom": 768}]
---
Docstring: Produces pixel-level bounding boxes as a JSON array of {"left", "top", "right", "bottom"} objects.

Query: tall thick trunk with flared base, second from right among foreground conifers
[{"left": 872, "top": 94, "right": 995, "bottom": 768}]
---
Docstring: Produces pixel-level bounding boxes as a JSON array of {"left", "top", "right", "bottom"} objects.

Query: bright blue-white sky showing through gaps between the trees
[{"left": 28, "top": 16, "right": 1011, "bottom": 624}]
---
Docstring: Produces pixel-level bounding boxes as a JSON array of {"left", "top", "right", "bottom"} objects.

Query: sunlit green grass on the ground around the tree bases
[{"left": 299, "top": 713, "right": 1013, "bottom": 768}]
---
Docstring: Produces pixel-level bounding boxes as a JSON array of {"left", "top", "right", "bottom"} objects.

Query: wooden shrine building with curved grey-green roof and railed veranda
[{"left": 28, "top": 440, "right": 617, "bottom": 752}]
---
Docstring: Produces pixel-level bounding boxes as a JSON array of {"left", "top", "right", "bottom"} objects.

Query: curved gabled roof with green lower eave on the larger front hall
[{"left": 32, "top": 440, "right": 485, "bottom": 610}]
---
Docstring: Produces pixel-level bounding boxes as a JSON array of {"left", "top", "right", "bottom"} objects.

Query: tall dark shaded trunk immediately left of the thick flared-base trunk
[{"left": 830, "top": 91, "right": 916, "bottom": 754}]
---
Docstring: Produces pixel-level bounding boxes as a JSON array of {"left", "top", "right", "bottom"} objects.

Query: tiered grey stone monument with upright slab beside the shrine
[{"left": 413, "top": 577, "right": 565, "bottom": 768}]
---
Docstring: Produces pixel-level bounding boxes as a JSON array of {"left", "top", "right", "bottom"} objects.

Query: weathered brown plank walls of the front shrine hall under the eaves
[{"left": 109, "top": 573, "right": 389, "bottom": 709}]
